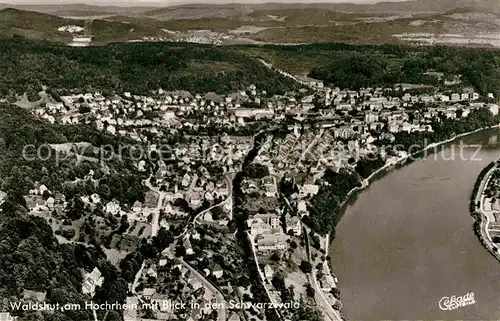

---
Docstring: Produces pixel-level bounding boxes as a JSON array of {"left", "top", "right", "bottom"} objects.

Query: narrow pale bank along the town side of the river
[{"left": 327, "top": 124, "right": 500, "bottom": 318}]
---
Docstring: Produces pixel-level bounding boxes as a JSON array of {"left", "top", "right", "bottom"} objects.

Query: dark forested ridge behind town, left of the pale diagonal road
[{"left": 0, "top": 37, "right": 296, "bottom": 96}]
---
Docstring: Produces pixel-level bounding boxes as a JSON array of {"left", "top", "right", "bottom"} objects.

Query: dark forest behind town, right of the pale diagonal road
[{"left": 234, "top": 43, "right": 500, "bottom": 96}]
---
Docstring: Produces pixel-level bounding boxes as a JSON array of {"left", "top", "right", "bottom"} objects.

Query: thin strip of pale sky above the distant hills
[{"left": 0, "top": 0, "right": 403, "bottom": 7}]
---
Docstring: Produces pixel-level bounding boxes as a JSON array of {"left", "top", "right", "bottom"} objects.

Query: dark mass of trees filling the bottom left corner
[{"left": 0, "top": 195, "right": 127, "bottom": 321}]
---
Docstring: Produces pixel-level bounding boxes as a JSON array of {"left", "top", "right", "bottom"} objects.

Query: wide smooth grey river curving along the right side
[{"left": 330, "top": 129, "right": 500, "bottom": 320}]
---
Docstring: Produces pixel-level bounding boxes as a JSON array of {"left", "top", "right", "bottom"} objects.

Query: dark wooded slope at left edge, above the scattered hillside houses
[{"left": 0, "top": 104, "right": 145, "bottom": 205}]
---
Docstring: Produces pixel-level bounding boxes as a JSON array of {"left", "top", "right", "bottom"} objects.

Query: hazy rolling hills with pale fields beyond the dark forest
[{"left": 0, "top": 0, "right": 500, "bottom": 46}]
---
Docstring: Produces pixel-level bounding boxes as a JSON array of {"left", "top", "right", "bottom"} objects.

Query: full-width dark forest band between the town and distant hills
[{"left": 0, "top": 37, "right": 500, "bottom": 97}]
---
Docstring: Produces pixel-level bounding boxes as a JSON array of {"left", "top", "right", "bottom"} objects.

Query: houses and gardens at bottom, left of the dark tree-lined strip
[{"left": 130, "top": 226, "right": 240, "bottom": 321}]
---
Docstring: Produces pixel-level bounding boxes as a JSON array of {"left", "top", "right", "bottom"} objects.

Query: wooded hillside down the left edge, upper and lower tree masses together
[{"left": 0, "top": 104, "right": 144, "bottom": 321}]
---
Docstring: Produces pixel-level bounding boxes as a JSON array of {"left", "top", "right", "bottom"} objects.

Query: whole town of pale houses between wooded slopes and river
[{"left": 2, "top": 64, "right": 499, "bottom": 321}]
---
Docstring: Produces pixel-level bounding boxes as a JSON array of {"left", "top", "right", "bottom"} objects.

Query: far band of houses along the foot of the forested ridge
[{"left": 35, "top": 79, "right": 498, "bottom": 150}]
